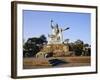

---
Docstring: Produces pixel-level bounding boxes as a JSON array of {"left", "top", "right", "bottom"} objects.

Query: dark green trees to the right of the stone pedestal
[{"left": 69, "top": 40, "right": 91, "bottom": 56}]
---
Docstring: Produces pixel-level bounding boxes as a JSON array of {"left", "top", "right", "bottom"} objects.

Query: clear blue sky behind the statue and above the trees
[{"left": 23, "top": 10, "right": 91, "bottom": 44}]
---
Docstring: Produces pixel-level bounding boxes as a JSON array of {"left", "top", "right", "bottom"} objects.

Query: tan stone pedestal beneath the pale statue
[{"left": 36, "top": 44, "right": 69, "bottom": 57}]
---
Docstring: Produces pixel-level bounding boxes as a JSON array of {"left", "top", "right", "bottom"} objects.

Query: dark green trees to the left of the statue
[{"left": 23, "top": 35, "right": 47, "bottom": 57}]
